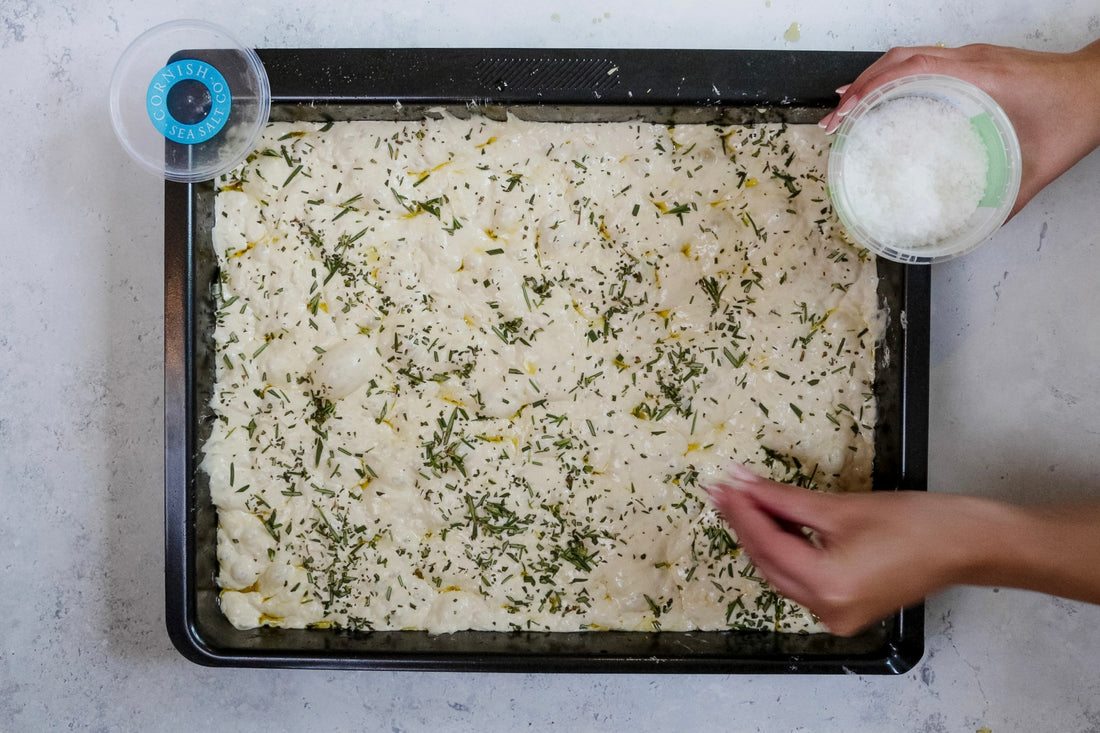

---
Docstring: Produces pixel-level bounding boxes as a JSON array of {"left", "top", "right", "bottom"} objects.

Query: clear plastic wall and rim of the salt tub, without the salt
[{"left": 828, "top": 74, "right": 1021, "bottom": 264}]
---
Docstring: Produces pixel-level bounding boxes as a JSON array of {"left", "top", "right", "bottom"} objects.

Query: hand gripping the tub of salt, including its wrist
[{"left": 821, "top": 41, "right": 1100, "bottom": 216}]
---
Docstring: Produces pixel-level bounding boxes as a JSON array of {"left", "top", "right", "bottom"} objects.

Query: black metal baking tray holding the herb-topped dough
[{"left": 165, "top": 48, "right": 930, "bottom": 675}]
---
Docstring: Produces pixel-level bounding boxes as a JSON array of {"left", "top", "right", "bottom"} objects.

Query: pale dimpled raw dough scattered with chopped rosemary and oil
[{"left": 201, "top": 117, "right": 880, "bottom": 633}]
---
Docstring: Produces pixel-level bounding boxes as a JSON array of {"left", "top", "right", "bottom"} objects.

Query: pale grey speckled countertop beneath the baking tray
[{"left": 0, "top": 0, "right": 1100, "bottom": 733}]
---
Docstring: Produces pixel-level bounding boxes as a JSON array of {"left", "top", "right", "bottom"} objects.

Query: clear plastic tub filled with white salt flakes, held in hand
[{"left": 828, "top": 74, "right": 1021, "bottom": 263}]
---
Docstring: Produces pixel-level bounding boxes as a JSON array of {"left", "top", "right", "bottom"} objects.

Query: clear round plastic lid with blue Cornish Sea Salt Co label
[{"left": 110, "top": 20, "right": 271, "bottom": 183}]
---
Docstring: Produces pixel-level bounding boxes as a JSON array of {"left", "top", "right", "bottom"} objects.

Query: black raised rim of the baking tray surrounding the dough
[{"left": 165, "top": 50, "right": 931, "bottom": 674}]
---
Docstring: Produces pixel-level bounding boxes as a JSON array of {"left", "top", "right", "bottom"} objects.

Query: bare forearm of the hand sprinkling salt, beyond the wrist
[{"left": 952, "top": 500, "right": 1100, "bottom": 603}]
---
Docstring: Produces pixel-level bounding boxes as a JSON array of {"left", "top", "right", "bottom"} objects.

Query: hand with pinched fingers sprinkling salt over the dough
[{"left": 707, "top": 466, "right": 1008, "bottom": 635}]
